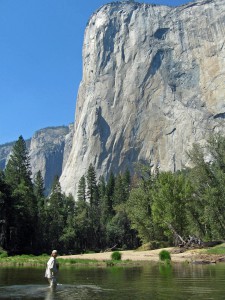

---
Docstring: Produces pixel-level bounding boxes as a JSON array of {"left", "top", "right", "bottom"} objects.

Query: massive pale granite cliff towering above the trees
[{"left": 60, "top": 0, "right": 225, "bottom": 195}]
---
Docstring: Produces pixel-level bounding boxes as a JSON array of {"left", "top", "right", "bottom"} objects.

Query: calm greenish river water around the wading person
[{"left": 0, "top": 263, "right": 225, "bottom": 300}]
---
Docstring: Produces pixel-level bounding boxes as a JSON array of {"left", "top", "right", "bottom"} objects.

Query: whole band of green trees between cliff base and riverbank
[{"left": 0, "top": 135, "right": 225, "bottom": 254}]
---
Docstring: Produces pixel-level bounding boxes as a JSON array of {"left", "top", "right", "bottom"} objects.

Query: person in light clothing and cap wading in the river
[{"left": 45, "top": 250, "right": 59, "bottom": 288}]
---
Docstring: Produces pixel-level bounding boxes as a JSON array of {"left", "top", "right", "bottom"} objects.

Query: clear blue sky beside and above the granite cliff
[{"left": 0, "top": 0, "right": 189, "bottom": 144}]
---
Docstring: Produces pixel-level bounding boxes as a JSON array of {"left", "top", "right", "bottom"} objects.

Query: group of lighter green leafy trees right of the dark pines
[{"left": 126, "top": 135, "right": 225, "bottom": 244}]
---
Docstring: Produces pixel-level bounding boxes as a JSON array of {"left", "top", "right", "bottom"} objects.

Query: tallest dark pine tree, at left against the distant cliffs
[{"left": 5, "top": 136, "right": 37, "bottom": 252}]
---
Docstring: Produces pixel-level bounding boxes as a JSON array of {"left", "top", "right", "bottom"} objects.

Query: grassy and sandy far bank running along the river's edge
[{"left": 0, "top": 247, "right": 225, "bottom": 267}]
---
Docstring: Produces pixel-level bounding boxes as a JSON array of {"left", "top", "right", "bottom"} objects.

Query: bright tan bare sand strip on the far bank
[{"left": 59, "top": 248, "right": 218, "bottom": 262}]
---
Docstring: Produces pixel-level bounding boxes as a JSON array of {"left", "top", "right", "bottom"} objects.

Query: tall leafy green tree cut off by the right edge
[{"left": 188, "top": 135, "right": 225, "bottom": 240}]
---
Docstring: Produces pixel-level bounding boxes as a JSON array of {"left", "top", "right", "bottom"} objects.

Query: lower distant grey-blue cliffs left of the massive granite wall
[{"left": 0, "top": 124, "right": 73, "bottom": 193}]
